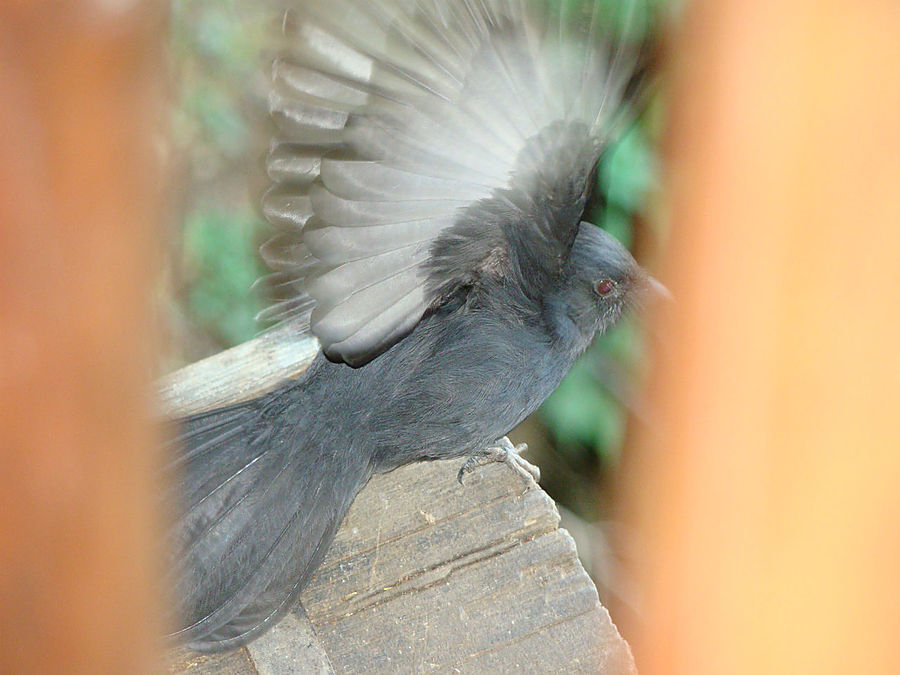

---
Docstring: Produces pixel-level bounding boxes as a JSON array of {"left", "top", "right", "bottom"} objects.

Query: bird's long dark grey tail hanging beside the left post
[{"left": 169, "top": 385, "right": 371, "bottom": 651}]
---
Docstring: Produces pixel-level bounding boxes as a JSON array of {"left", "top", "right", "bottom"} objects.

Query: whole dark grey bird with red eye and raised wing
[{"left": 166, "top": 0, "right": 659, "bottom": 652}]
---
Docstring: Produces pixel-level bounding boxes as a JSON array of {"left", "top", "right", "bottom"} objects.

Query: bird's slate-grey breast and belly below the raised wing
[{"left": 362, "top": 314, "right": 571, "bottom": 468}]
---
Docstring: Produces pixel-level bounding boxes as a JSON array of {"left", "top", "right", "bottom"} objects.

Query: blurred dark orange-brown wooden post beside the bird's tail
[{"left": 0, "top": 0, "right": 164, "bottom": 673}]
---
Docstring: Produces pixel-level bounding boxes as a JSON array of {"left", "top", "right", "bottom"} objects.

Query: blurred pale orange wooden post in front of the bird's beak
[{"left": 630, "top": 0, "right": 900, "bottom": 675}]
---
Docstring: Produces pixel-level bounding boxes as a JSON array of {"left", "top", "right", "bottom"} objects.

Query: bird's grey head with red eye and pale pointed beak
[{"left": 547, "top": 223, "right": 668, "bottom": 351}]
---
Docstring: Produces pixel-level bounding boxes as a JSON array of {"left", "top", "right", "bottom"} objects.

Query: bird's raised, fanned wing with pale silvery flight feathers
[{"left": 263, "top": 0, "right": 648, "bottom": 366}]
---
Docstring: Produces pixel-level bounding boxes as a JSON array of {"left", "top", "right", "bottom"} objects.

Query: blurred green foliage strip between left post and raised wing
[{"left": 170, "top": 0, "right": 273, "bottom": 358}]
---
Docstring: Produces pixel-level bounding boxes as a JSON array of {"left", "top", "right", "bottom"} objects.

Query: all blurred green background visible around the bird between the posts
[{"left": 165, "top": 0, "right": 662, "bottom": 612}]
